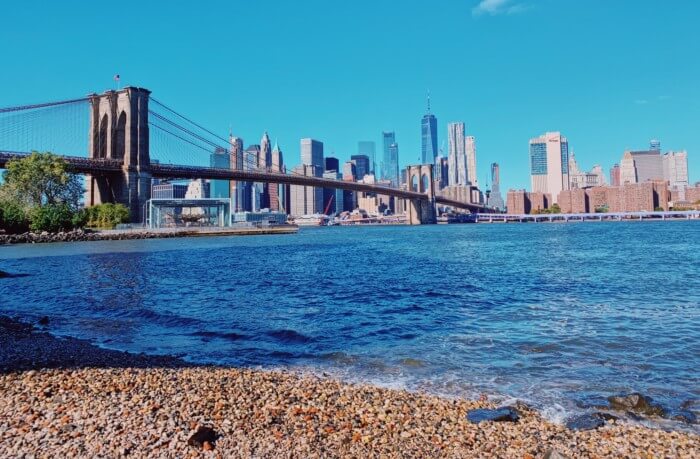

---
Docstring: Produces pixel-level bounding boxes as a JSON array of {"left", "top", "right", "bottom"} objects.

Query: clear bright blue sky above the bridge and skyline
[{"left": 0, "top": 0, "right": 700, "bottom": 189}]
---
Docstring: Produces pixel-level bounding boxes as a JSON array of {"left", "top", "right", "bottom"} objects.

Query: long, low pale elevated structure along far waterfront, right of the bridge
[{"left": 477, "top": 210, "right": 700, "bottom": 223}]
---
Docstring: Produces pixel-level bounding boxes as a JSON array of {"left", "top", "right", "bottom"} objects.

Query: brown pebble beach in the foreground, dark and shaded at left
[{"left": 0, "top": 318, "right": 700, "bottom": 459}]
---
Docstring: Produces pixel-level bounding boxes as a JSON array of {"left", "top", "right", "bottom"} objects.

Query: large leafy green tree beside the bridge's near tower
[{"left": 2, "top": 151, "right": 84, "bottom": 210}]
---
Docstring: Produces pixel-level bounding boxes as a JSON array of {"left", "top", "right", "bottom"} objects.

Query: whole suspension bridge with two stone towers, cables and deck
[{"left": 0, "top": 87, "right": 490, "bottom": 224}]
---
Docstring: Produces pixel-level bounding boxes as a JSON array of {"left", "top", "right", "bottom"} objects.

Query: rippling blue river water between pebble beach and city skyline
[{"left": 0, "top": 222, "right": 700, "bottom": 432}]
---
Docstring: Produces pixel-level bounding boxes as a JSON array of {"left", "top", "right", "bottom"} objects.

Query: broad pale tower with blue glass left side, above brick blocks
[{"left": 530, "top": 132, "right": 570, "bottom": 202}]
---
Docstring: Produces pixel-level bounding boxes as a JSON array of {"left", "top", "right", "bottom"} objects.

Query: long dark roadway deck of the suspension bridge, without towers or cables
[{"left": 0, "top": 151, "right": 491, "bottom": 213}]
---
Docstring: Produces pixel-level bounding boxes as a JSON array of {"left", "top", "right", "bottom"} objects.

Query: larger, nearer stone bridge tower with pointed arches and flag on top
[{"left": 85, "top": 87, "right": 151, "bottom": 223}]
